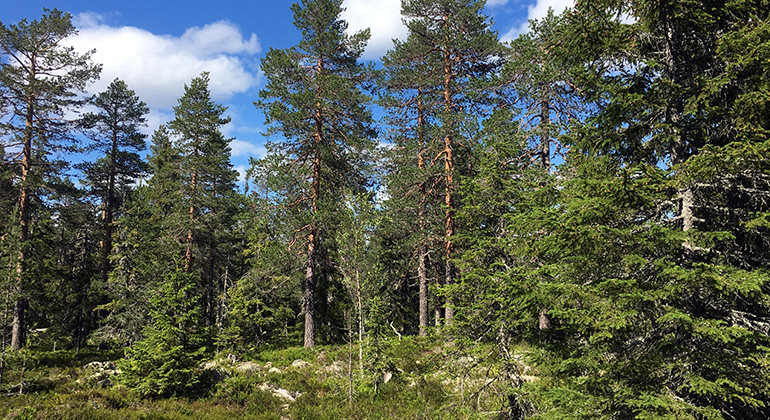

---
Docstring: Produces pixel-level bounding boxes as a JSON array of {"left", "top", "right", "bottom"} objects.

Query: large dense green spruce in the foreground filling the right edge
[{"left": 484, "top": 2, "right": 770, "bottom": 418}]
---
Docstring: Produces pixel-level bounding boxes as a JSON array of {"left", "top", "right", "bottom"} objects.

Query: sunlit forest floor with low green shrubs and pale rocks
[{"left": 0, "top": 337, "right": 524, "bottom": 420}]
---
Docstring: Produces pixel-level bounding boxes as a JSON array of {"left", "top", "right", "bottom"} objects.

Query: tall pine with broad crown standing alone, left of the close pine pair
[{"left": 257, "top": 0, "right": 374, "bottom": 347}]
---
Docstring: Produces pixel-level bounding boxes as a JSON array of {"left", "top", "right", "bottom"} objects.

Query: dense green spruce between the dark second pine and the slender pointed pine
[{"left": 93, "top": 125, "right": 186, "bottom": 346}]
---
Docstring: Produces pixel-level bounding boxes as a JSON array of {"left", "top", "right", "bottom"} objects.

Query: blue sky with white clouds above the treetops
[{"left": 0, "top": 0, "right": 572, "bottom": 181}]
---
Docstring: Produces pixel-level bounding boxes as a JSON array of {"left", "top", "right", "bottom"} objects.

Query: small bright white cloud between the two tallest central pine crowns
[{"left": 342, "top": 0, "right": 406, "bottom": 60}]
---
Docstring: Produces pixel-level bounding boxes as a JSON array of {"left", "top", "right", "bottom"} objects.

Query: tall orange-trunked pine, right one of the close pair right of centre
[{"left": 402, "top": 0, "right": 500, "bottom": 323}]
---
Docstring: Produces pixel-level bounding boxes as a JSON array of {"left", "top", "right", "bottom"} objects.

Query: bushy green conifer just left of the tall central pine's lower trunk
[{"left": 219, "top": 159, "right": 304, "bottom": 349}]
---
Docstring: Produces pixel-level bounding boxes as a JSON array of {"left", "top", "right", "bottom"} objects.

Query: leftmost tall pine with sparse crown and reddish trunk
[{"left": 0, "top": 9, "right": 101, "bottom": 349}]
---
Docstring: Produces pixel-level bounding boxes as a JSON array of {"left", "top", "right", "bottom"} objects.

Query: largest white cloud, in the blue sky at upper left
[{"left": 72, "top": 13, "right": 260, "bottom": 109}]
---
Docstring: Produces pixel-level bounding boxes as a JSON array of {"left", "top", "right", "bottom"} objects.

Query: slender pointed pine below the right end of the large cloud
[{"left": 168, "top": 72, "right": 237, "bottom": 323}]
